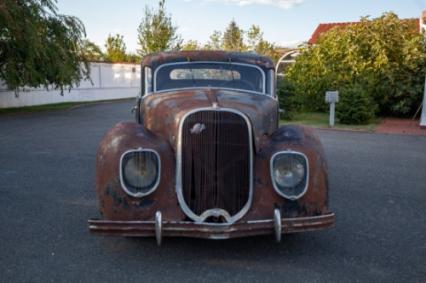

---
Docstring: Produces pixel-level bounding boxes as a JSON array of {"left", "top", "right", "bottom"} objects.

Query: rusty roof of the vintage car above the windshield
[{"left": 142, "top": 50, "right": 275, "bottom": 70}]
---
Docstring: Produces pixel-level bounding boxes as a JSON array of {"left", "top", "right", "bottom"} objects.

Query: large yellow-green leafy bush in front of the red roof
[{"left": 287, "top": 13, "right": 426, "bottom": 116}]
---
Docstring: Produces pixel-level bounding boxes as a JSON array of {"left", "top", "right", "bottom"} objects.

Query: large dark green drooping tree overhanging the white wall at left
[{"left": 0, "top": 0, "right": 89, "bottom": 92}]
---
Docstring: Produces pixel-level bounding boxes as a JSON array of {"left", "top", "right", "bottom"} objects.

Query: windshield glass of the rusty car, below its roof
[{"left": 154, "top": 62, "right": 265, "bottom": 93}]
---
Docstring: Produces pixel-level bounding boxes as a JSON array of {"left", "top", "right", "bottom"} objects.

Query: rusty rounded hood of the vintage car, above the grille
[{"left": 141, "top": 89, "right": 278, "bottom": 152}]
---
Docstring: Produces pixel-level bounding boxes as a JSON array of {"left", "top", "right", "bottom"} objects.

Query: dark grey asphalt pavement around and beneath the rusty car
[{"left": 0, "top": 101, "right": 426, "bottom": 282}]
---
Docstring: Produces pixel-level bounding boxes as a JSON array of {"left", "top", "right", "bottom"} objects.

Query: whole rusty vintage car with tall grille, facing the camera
[{"left": 89, "top": 51, "right": 335, "bottom": 244}]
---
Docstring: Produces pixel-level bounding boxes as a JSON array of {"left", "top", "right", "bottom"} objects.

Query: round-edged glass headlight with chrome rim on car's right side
[{"left": 270, "top": 151, "right": 309, "bottom": 200}]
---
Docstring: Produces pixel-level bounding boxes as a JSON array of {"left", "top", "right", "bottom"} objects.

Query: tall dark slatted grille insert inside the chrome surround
[{"left": 182, "top": 111, "right": 251, "bottom": 215}]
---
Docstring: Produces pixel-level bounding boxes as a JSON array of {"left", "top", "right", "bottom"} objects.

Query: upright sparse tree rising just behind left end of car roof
[{"left": 138, "top": 0, "right": 182, "bottom": 56}]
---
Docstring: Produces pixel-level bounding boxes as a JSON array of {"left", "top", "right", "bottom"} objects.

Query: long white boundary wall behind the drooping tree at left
[{"left": 0, "top": 63, "right": 140, "bottom": 108}]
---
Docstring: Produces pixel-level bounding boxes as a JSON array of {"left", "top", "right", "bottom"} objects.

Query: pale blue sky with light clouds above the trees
[{"left": 57, "top": 0, "right": 426, "bottom": 52}]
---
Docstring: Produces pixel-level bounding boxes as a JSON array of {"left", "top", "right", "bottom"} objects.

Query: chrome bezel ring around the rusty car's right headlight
[{"left": 269, "top": 150, "right": 309, "bottom": 200}]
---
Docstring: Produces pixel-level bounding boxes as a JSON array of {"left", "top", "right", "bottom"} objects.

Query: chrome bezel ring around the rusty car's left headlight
[{"left": 119, "top": 148, "right": 161, "bottom": 198}]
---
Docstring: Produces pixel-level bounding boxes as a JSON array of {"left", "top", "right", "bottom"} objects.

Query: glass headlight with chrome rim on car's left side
[{"left": 120, "top": 149, "right": 161, "bottom": 197}]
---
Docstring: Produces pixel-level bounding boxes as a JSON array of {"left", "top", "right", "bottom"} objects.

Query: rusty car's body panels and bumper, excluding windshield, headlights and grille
[{"left": 89, "top": 51, "right": 335, "bottom": 240}]
